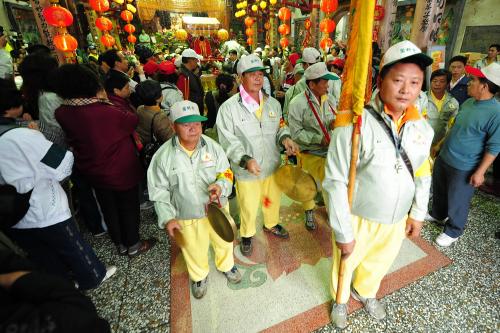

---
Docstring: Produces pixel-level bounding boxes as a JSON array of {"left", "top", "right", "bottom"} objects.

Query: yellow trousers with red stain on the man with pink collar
[{"left": 236, "top": 174, "right": 281, "bottom": 237}]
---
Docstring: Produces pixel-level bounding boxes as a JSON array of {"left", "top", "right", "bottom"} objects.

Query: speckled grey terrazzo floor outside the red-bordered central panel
[{"left": 85, "top": 193, "right": 500, "bottom": 332}]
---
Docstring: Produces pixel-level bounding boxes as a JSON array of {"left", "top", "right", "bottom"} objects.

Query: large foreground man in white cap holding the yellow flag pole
[{"left": 323, "top": 41, "right": 433, "bottom": 327}]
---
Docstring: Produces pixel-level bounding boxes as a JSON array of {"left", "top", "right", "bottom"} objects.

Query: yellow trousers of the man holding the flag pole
[{"left": 330, "top": 216, "right": 406, "bottom": 304}]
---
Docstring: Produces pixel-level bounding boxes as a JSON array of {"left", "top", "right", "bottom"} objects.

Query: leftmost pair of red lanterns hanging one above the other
[{"left": 42, "top": 0, "right": 78, "bottom": 52}]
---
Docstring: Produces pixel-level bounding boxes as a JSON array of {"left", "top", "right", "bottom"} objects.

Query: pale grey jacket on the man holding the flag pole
[{"left": 323, "top": 94, "right": 433, "bottom": 243}]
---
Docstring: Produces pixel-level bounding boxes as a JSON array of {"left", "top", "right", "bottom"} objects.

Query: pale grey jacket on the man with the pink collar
[{"left": 216, "top": 94, "right": 290, "bottom": 180}]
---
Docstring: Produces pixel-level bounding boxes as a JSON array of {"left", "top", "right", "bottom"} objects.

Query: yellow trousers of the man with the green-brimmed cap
[{"left": 179, "top": 207, "right": 234, "bottom": 282}]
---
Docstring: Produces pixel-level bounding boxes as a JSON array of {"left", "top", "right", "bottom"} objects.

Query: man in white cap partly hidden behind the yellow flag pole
[{"left": 288, "top": 62, "right": 339, "bottom": 230}]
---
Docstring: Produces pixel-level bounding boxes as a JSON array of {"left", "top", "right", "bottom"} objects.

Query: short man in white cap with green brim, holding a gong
[{"left": 148, "top": 101, "right": 241, "bottom": 298}]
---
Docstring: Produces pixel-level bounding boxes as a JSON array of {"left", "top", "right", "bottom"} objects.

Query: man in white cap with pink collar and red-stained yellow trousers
[{"left": 217, "top": 54, "right": 299, "bottom": 256}]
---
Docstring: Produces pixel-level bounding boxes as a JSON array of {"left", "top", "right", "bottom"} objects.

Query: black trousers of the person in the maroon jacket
[{"left": 95, "top": 185, "right": 140, "bottom": 247}]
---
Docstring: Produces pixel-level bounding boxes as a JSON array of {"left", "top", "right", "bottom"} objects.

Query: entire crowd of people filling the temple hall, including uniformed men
[{"left": 0, "top": 31, "right": 500, "bottom": 332}]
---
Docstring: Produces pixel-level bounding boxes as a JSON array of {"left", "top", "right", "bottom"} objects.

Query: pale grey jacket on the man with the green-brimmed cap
[{"left": 148, "top": 135, "right": 232, "bottom": 228}]
